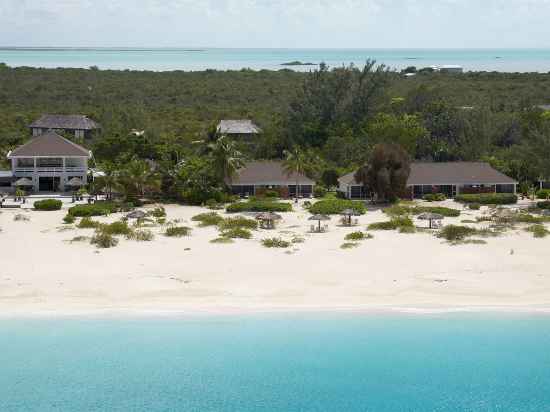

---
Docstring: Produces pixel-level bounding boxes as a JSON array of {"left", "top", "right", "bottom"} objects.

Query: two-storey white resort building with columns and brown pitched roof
[{"left": 8, "top": 131, "right": 92, "bottom": 192}]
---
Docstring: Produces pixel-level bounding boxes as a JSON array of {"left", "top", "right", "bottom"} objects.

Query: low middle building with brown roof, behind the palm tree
[{"left": 228, "top": 161, "right": 315, "bottom": 197}]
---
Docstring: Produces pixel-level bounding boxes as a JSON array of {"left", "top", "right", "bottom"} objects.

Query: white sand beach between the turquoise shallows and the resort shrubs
[{"left": 0, "top": 202, "right": 550, "bottom": 316}]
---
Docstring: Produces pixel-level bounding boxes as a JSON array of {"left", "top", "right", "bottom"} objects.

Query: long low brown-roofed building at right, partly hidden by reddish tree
[{"left": 338, "top": 162, "right": 518, "bottom": 199}]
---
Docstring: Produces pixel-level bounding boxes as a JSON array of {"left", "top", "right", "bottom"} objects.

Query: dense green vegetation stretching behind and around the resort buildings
[{"left": 0, "top": 62, "right": 550, "bottom": 204}]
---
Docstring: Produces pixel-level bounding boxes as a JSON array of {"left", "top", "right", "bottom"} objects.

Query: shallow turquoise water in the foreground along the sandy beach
[{"left": 0, "top": 314, "right": 550, "bottom": 412}]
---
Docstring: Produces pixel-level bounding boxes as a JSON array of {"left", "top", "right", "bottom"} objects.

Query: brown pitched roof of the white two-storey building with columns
[{"left": 8, "top": 131, "right": 90, "bottom": 158}]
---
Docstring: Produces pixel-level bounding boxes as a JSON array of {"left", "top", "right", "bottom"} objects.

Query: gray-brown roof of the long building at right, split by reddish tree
[{"left": 338, "top": 162, "right": 517, "bottom": 186}]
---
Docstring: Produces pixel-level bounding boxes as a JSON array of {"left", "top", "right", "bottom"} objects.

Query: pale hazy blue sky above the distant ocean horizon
[{"left": 0, "top": 0, "right": 550, "bottom": 48}]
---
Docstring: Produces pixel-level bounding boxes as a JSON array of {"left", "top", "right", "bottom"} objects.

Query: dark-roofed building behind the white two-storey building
[{"left": 29, "top": 114, "right": 101, "bottom": 139}]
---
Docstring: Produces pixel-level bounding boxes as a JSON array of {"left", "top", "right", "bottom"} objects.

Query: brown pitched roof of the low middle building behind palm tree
[{"left": 231, "top": 160, "right": 315, "bottom": 186}]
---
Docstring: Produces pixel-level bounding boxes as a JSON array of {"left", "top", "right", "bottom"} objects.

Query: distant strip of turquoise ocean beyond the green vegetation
[{"left": 0, "top": 48, "right": 550, "bottom": 73}]
